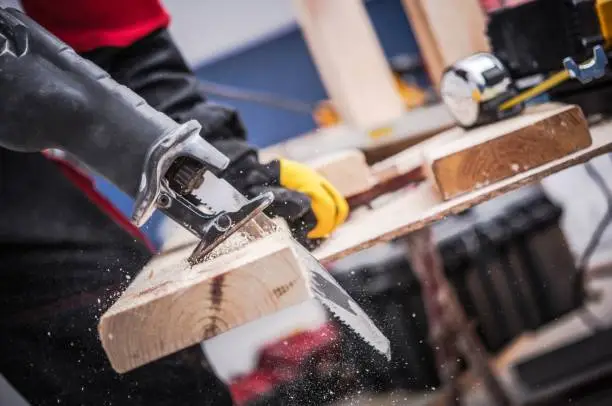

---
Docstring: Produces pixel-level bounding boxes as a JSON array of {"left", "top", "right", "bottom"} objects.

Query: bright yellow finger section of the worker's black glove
[{"left": 280, "top": 159, "right": 349, "bottom": 239}]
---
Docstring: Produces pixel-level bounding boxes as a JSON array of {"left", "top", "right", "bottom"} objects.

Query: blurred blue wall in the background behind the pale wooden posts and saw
[{"left": 98, "top": 0, "right": 418, "bottom": 247}]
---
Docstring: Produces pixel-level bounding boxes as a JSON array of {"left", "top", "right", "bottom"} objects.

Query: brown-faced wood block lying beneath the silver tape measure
[{"left": 423, "top": 104, "right": 591, "bottom": 200}]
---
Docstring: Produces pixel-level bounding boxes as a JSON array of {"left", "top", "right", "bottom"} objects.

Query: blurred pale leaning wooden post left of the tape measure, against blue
[{"left": 294, "top": 0, "right": 405, "bottom": 131}]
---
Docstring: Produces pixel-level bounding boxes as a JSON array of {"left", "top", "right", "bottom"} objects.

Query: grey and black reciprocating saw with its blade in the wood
[{"left": 0, "top": 8, "right": 390, "bottom": 357}]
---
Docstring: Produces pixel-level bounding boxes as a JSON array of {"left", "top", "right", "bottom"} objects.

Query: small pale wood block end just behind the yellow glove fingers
[{"left": 306, "top": 150, "right": 376, "bottom": 197}]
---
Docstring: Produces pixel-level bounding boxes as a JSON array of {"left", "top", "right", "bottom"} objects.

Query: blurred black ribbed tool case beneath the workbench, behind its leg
[{"left": 331, "top": 186, "right": 584, "bottom": 389}]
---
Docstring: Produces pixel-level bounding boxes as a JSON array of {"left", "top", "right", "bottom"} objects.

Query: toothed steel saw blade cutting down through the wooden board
[{"left": 194, "top": 173, "right": 391, "bottom": 359}]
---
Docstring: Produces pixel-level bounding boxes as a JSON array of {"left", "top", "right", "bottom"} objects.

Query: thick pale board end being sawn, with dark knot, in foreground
[{"left": 99, "top": 228, "right": 313, "bottom": 373}]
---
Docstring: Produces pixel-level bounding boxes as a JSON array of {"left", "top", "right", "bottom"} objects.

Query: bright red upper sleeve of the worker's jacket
[{"left": 21, "top": 0, "right": 170, "bottom": 52}]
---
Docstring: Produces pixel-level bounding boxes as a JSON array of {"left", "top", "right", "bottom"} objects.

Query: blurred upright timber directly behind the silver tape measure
[{"left": 402, "top": 0, "right": 490, "bottom": 87}]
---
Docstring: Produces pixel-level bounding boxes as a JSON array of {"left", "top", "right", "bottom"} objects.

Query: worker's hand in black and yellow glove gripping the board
[{"left": 213, "top": 140, "right": 349, "bottom": 249}]
